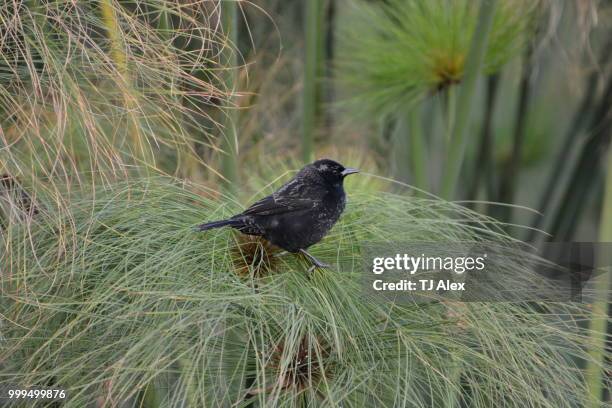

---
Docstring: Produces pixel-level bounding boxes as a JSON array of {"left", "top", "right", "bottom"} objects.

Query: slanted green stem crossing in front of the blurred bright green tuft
[{"left": 442, "top": 0, "right": 497, "bottom": 199}]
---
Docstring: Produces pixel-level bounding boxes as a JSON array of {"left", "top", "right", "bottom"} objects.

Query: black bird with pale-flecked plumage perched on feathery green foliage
[{"left": 197, "top": 159, "right": 359, "bottom": 270}]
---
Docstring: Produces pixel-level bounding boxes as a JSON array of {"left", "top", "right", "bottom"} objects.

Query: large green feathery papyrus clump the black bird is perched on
[{"left": 0, "top": 179, "right": 604, "bottom": 407}]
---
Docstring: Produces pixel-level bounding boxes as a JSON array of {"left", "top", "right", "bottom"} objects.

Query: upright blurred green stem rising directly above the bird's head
[{"left": 302, "top": 0, "right": 323, "bottom": 162}]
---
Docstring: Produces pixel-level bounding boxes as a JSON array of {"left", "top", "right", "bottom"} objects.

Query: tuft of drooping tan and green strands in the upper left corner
[{"left": 0, "top": 0, "right": 234, "bottom": 181}]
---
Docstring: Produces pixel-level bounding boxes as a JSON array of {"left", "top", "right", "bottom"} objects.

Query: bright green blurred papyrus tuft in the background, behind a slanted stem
[{"left": 338, "top": 0, "right": 537, "bottom": 112}]
